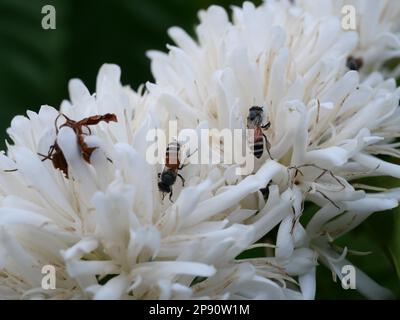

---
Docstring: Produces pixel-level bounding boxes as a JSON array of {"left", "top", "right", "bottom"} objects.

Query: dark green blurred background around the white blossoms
[{"left": 0, "top": 0, "right": 400, "bottom": 299}]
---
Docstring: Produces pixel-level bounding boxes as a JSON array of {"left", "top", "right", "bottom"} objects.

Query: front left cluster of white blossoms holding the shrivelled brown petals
[{"left": 0, "top": 65, "right": 300, "bottom": 299}]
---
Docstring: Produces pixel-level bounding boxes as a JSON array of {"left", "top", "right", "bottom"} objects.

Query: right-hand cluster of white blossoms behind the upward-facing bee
[{"left": 148, "top": 1, "right": 400, "bottom": 298}]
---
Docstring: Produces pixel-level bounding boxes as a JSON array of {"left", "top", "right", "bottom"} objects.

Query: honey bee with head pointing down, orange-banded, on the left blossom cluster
[{"left": 158, "top": 141, "right": 185, "bottom": 201}]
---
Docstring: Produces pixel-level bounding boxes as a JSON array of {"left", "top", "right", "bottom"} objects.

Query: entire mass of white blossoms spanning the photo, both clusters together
[{"left": 0, "top": 0, "right": 400, "bottom": 299}]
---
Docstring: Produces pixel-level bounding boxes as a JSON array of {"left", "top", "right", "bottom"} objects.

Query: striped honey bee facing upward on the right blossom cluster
[{"left": 247, "top": 106, "right": 272, "bottom": 159}]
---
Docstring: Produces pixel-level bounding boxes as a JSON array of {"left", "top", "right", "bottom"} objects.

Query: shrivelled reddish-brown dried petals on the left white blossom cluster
[{"left": 39, "top": 113, "right": 117, "bottom": 178}]
